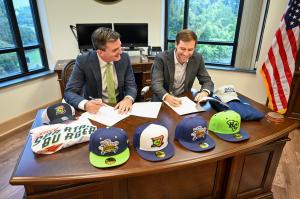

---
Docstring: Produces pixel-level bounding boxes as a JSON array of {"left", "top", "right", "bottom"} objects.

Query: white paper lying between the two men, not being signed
[{"left": 130, "top": 102, "right": 161, "bottom": 118}]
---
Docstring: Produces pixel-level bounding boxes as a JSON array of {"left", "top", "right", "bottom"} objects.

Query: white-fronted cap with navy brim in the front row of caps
[{"left": 133, "top": 123, "right": 174, "bottom": 161}]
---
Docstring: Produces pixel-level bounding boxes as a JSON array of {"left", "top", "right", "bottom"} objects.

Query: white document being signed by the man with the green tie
[{"left": 81, "top": 105, "right": 130, "bottom": 126}]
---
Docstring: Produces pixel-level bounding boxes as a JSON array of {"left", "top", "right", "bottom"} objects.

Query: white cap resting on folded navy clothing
[{"left": 214, "top": 85, "right": 240, "bottom": 103}]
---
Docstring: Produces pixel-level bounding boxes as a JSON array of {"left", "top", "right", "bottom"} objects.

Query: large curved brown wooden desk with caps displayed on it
[{"left": 10, "top": 93, "right": 298, "bottom": 199}]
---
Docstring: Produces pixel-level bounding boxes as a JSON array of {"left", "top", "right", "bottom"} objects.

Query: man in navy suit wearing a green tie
[{"left": 64, "top": 28, "right": 137, "bottom": 113}]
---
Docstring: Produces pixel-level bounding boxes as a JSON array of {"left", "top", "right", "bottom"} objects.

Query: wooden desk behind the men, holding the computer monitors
[{"left": 54, "top": 56, "right": 153, "bottom": 101}]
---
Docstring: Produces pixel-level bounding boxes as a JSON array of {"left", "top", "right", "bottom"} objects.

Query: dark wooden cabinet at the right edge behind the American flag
[{"left": 286, "top": 71, "right": 300, "bottom": 120}]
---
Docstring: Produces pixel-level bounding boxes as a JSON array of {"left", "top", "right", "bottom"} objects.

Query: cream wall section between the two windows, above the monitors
[{"left": 40, "top": 0, "right": 163, "bottom": 67}]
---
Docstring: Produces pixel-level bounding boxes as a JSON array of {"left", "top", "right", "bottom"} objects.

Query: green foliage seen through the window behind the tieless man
[{"left": 168, "top": 0, "right": 240, "bottom": 65}]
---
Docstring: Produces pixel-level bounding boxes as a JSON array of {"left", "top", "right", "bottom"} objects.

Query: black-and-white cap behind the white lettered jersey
[{"left": 42, "top": 103, "right": 76, "bottom": 124}]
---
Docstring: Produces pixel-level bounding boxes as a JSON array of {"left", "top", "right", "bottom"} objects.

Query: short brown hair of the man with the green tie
[{"left": 92, "top": 27, "right": 120, "bottom": 50}]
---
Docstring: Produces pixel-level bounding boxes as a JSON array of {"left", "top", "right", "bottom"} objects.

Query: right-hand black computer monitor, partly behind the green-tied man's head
[{"left": 114, "top": 23, "right": 148, "bottom": 49}]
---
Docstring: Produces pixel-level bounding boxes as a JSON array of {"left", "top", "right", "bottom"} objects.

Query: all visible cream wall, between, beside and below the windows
[{"left": 0, "top": 0, "right": 287, "bottom": 123}]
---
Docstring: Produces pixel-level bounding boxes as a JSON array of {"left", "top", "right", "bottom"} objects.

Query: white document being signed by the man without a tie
[{"left": 165, "top": 97, "right": 205, "bottom": 115}]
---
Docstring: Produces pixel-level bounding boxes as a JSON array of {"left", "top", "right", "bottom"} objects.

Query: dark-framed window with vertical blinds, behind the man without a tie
[{"left": 165, "top": 0, "right": 268, "bottom": 69}]
